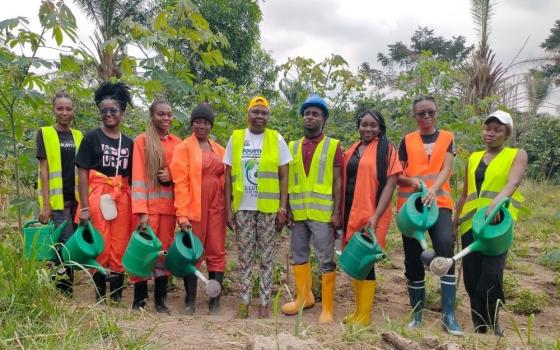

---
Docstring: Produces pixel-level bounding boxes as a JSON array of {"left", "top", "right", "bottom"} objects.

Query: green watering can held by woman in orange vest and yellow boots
[{"left": 338, "top": 227, "right": 386, "bottom": 280}]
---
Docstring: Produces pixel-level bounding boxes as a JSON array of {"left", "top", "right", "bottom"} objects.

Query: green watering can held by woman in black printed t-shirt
[{"left": 62, "top": 221, "right": 107, "bottom": 275}]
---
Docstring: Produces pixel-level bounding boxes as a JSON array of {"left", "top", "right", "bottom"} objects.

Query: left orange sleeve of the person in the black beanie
[{"left": 169, "top": 141, "right": 191, "bottom": 222}]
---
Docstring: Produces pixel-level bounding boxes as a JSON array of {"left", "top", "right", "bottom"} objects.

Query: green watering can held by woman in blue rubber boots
[{"left": 396, "top": 182, "right": 439, "bottom": 265}]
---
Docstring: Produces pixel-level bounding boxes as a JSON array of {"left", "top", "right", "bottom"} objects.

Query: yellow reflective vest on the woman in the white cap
[{"left": 459, "top": 147, "right": 524, "bottom": 235}]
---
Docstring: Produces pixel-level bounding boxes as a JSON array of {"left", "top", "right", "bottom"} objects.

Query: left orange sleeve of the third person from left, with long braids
[{"left": 131, "top": 134, "right": 148, "bottom": 214}]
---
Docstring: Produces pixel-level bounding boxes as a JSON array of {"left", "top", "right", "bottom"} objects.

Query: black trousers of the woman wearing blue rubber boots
[{"left": 402, "top": 208, "right": 455, "bottom": 281}]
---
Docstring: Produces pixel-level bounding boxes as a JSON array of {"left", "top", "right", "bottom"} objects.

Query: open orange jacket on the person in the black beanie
[{"left": 169, "top": 134, "right": 225, "bottom": 222}]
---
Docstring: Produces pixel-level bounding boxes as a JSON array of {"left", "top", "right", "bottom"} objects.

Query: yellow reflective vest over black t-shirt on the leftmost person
[{"left": 37, "top": 126, "right": 83, "bottom": 210}]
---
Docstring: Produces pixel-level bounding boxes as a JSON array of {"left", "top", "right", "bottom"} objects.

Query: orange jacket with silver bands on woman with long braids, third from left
[{"left": 131, "top": 134, "right": 181, "bottom": 215}]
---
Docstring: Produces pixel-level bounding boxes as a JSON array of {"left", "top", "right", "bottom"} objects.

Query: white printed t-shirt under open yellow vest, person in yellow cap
[{"left": 224, "top": 129, "right": 292, "bottom": 210}]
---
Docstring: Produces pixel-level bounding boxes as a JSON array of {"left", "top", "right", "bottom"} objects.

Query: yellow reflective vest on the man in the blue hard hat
[{"left": 288, "top": 137, "right": 339, "bottom": 222}]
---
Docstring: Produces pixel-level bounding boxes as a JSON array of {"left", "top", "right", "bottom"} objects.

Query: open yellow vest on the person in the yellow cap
[{"left": 231, "top": 129, "right": 280, "bottom": 213}]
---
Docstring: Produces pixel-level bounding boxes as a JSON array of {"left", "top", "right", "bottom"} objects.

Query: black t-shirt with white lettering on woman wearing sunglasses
[{"left": 76, "top": 128, "right": 134, "bottom": 179}]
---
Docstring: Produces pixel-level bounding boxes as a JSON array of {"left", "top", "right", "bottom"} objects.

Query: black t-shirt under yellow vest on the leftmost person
[{"left": 36, "top": 129, "right": 76, "bottom": 202}]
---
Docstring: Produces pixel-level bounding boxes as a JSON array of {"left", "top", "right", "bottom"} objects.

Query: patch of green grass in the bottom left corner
[{"left": 0, "top": 231, "right": 149, "bottom": 349}]
